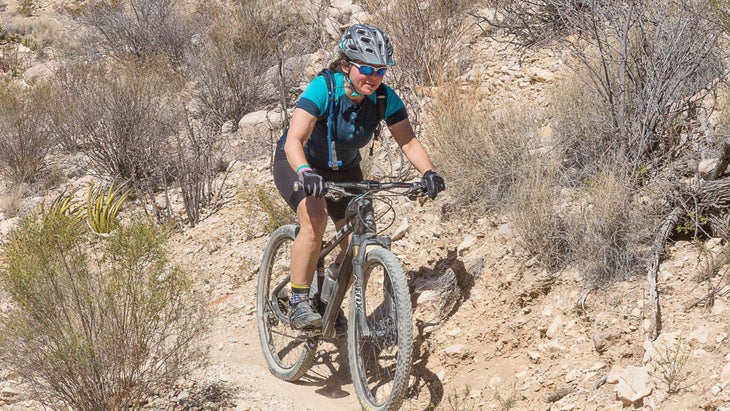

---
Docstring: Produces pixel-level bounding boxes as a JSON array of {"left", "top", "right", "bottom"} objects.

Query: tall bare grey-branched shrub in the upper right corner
[{"left": 495, "top": 0, "right": 726, "bottom": 170}]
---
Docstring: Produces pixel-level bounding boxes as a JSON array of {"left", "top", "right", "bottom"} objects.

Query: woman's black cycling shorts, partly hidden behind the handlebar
[{"left": 273, "top": 148, "right": 363, "bottom": 222}]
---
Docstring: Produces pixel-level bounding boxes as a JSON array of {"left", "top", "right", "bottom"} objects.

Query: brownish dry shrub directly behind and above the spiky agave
[{"left": 54, "top": 60, "right": 180, "bottom": 188}]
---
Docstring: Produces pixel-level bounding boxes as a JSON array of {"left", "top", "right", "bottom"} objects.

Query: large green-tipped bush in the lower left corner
[{"left": 0, "top": 201, "right": 206, "bottom": 410}]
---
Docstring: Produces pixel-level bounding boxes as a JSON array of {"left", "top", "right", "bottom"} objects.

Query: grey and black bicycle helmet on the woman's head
[{"left": 340, "top": 24, "right": 395, "bottom": 66}]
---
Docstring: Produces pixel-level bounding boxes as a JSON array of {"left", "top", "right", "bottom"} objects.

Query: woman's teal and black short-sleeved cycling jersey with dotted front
[{"left": 281, "top": 73, "right": 408, "bottom": 170}]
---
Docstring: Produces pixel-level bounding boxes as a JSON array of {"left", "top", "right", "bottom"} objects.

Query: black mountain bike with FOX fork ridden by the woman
[{"left": 256, "top": 181, "right": 426, "bottom": 410}]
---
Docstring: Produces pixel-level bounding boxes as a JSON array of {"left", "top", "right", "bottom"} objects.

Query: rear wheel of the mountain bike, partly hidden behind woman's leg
[{"left": 256, "top": 225, "right": 317, "bottom": 381}]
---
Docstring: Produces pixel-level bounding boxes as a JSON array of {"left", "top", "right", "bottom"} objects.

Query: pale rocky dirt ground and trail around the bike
[{"left": 0, "top": 2, "right": 730, "bottom": 411}]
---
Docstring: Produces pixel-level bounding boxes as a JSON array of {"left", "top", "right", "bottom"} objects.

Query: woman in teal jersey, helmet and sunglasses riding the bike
[{"left": 273, "top": 24, "right": 446, "bottom": 329}]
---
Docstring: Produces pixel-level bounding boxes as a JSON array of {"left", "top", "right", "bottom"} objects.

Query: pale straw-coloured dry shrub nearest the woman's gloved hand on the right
[{"left": 426, "top": 85, "right": 538, "bottom": 214}]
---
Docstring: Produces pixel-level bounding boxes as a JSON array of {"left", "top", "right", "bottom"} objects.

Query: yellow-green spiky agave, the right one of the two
[{"left": 86, "top": 181, "right": 132, "bottom": 234}]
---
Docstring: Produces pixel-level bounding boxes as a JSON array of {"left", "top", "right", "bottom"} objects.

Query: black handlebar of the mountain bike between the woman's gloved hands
[{"left": 294, "top": 180, "right": 428, "bottom": 201}]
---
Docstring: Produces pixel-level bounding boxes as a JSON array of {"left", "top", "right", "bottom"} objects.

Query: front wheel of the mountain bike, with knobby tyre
[{"left": 347, "top": 248, "right": 413, "bottom": 411}]
